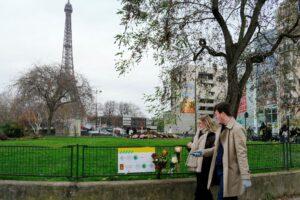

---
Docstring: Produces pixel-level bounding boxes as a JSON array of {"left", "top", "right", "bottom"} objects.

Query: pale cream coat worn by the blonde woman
[{"left": 186, "top": 129, "right": 214, "bottom": 172}]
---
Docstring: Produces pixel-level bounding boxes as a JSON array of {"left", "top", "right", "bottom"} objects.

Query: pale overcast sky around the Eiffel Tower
[{"left": 0, "top": 0, "right": 159, "bottom": 116}]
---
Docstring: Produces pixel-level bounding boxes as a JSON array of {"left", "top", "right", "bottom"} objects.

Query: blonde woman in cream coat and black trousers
[{"left": 186, "top": 115, "right": 217, "bottom": 200}]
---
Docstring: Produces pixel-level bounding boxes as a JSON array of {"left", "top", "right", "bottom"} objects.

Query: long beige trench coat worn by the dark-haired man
[{"left": 207, "top": 118, "right": 250, "bottom": 197}]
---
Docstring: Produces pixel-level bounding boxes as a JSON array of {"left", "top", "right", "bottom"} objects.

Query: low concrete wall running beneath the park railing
[{"left": 0, "top": 170, "right": 300, "bottom": 200}]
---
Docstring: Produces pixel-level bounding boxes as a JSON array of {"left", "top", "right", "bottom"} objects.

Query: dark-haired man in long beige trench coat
[{"left": 207, "top": 102, "right": 251, "bottom": 200}]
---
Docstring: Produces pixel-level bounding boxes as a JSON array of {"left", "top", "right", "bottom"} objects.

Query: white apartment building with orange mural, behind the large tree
[{"left": 164, "top": 66, "right": 225, "bottom": 134}]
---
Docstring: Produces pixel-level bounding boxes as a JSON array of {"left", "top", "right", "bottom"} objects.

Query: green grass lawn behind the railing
[{"left": 0, "top": 137, "right": 300, "bottom": 180}]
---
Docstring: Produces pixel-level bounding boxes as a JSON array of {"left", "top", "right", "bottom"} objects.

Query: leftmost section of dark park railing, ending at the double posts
[{"left": 0, "top": 146, "right": 74, "bottom": 177}]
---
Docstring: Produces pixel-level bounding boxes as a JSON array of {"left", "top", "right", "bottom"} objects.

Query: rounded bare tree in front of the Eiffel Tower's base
[{"left": 14, "top": 65, "right": 92, "bottom": 134}]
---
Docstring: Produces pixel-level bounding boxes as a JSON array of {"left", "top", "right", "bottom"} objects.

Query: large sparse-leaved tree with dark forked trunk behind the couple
[{"left": 116, "top": 0, "right": 300, "bottom": 116}]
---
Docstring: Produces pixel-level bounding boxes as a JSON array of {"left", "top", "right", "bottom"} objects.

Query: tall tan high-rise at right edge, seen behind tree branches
[{"left": 276, "top": 0, "right": 300, "bottom": 126}]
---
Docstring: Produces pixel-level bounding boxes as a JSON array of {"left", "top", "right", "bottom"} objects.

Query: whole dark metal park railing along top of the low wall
[{"left": 0, "top": 143, "right": 300, "bottom": 180}]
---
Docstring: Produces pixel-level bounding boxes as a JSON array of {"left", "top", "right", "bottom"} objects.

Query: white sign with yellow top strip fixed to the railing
[{"left": 118, "top": 147, "right": 155, "bottom": 174}]
